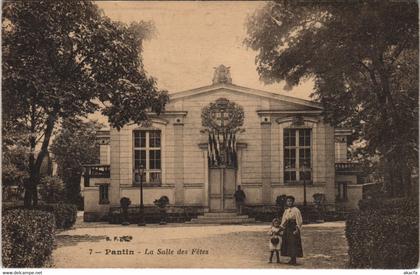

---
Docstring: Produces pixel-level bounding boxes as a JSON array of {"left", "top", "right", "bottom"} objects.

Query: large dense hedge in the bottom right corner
[{"left": 346, "top": 199, "right": 419, "bottom": 269}]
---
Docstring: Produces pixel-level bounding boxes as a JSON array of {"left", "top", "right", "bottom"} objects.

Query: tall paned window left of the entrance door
[{"left": 134, "top": 130, "right": 162, "bottom": 183}]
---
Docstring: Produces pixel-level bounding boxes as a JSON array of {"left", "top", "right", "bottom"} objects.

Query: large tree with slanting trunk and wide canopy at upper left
[{"left": 2, "top": 0, "right": 168, "bottom": 207}]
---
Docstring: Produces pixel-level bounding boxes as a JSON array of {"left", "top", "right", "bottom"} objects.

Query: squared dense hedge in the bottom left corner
[{"left": 2, "top": 209, "right": 54, "bottom": 268}]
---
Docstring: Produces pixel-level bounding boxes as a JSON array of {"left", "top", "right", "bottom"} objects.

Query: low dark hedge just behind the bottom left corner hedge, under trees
[{"left": 37, "top": 203, "right": 77, "bottom": 229}]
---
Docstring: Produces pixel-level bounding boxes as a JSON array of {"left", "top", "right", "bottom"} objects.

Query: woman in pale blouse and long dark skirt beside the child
[{"left": 280, "top": 196, "right": 303, "bottom": 265}]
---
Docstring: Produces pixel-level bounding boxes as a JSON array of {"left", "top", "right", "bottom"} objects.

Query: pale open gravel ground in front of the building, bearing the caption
[{"left": 53, "top": 222, "right": 347, "bottom": 268}]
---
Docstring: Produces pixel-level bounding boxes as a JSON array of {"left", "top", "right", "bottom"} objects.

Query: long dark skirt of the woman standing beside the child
[{"left": 281, "top": 220, "right": 303, "bottom": 257}]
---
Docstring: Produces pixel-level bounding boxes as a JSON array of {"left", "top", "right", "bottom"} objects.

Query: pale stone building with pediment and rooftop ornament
[{"left": 83, "top": 66, "right": 362, "bottom": 220}]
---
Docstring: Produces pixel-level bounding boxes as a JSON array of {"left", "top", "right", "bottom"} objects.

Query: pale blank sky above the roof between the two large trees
[{"left": 96, "top": 1, "right": 313, "bottom": 99}]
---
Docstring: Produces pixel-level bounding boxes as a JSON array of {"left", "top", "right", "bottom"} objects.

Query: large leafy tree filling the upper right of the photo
[{"left": 245, "top": 0, "right": 419, "bottom": 196}]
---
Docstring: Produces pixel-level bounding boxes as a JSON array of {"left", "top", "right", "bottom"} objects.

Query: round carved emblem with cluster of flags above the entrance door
[{"left": 201, "top": 98, "right": 244, "bottom": 168}]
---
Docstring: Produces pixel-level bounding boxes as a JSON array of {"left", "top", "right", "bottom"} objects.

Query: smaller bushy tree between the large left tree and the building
[{"left": 51, "top": 119, "right": 103, "bottom": 208}]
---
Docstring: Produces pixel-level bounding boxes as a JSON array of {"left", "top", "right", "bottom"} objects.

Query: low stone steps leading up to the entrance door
[{"left": 186, "top": 212, "right": 255, "bottom": 224}]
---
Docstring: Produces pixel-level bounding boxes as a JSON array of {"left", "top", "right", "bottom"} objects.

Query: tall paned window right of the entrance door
[{"left": 283, "top": 129, "right": 312, "bottom": 182}]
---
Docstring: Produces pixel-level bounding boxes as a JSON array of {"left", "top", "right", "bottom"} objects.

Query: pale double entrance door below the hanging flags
[{"left": 209, "top": 167, "right": 236, "bottom": 212}]
